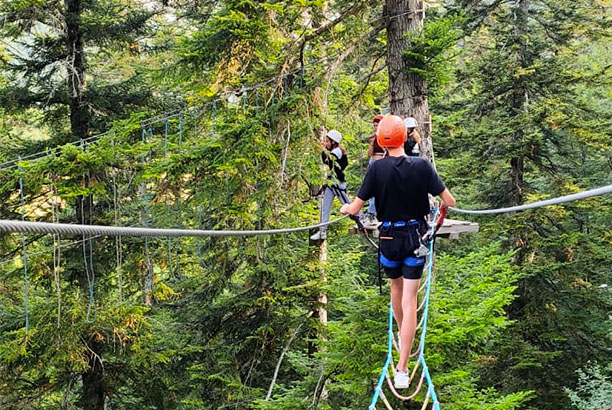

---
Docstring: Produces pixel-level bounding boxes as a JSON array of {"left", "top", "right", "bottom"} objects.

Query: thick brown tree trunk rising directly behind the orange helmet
[{"left": 385, "top": 0, "right": 434, "bottom": 163}]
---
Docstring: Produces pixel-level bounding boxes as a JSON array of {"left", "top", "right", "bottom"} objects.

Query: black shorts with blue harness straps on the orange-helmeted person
[{"left": 378, "top": 220, "right": 427, "bottom": 279}]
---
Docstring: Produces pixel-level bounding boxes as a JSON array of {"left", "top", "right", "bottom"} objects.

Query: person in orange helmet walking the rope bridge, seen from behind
[{"left": 340, "top": 115, "right": 455, "bottom": 389}]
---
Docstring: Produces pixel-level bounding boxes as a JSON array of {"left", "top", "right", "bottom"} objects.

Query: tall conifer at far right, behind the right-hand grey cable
[{"left": 438, "top": 0, "right": 611, "bottom": 409}]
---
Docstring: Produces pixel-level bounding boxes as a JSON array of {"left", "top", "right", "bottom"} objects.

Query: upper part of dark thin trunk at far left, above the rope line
[{"left": 64, "top": 0, "right": 89, "bottom": 139}]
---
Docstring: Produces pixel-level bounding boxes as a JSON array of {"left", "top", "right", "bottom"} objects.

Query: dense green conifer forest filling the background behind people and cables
[{"left": 0, "top": 0, "right": 612, "bottom": 410}]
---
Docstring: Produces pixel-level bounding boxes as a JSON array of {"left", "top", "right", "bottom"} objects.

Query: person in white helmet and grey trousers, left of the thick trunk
[{"left": 310, "top": 130, "right": 363, "bottom": 241}]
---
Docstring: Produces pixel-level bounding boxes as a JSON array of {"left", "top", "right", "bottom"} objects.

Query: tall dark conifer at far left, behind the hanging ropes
[{"left": 0, "top": 0, "right": 161, "bottom": 410}]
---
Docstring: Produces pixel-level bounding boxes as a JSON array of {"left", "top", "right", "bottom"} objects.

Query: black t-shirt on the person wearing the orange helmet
[{"left": 357, "top": 156, "right": 446, "bottom": 222}]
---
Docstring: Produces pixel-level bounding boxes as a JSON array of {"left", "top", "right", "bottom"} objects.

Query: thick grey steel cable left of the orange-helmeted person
[{"left": 0, "top": 215, "right": 348, "bottom": 237}]
